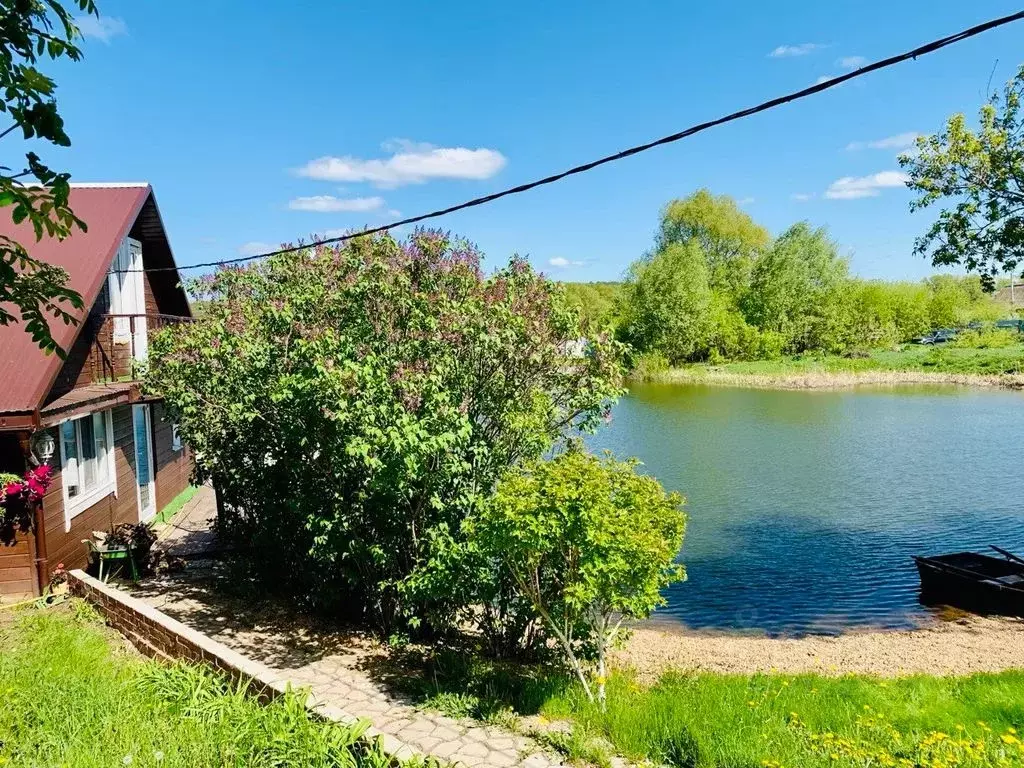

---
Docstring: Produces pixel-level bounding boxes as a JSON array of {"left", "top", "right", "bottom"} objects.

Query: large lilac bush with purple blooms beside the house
[{"left": 148, "top": 230, "right": 622, "bottom": 629}]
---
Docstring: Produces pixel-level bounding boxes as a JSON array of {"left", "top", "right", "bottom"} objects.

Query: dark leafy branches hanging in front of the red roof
[{"left": 0, "top": 0, "right": 96, "bottom": 356}]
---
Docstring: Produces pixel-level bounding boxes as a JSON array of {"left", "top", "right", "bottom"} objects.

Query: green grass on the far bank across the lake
[{"left": 669, "top": 344, "right": 1024, "bottom": 377}]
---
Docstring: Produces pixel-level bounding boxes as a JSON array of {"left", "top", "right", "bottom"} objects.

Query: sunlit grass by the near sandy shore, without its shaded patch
[{"left": 542, "top": 673, "right": 1024, "bottom": 768}]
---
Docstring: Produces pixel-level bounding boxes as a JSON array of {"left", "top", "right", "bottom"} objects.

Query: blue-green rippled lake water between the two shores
[{"left": 590, "top": 384, "right": 1024, "bottom": 634}]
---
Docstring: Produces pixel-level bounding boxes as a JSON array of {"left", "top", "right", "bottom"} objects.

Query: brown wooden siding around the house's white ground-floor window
[{"left": 37, "top": 406, "right": 138, "bottom": 570}]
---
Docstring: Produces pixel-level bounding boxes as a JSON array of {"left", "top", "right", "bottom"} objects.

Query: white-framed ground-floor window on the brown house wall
[{"left": 59, "top": 411, "right": 117, "bottom": 530}]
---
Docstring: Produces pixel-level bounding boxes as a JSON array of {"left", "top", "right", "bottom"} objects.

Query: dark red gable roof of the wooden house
[{"left": 0, "top": 183, "right": 190, "bottom": 413}]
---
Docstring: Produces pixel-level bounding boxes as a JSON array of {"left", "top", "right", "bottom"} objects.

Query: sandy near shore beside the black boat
[{"left": 616, "top": 616, "right": 1024, "bottom": 682}]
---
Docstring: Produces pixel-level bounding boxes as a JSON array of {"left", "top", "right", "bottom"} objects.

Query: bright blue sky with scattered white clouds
[{"left": 44, "top": 0, "right": 1024, "bottom": 280}]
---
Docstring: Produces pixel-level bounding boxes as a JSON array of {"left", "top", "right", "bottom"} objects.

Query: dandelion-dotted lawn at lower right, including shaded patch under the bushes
[{"left": 407, "top": 650, "right": 1024, "bottom": 768}]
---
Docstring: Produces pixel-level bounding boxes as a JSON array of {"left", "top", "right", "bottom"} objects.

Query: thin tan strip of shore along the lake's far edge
[{"left": 638, "top": 368, "right": 1024, "bottom": 389}]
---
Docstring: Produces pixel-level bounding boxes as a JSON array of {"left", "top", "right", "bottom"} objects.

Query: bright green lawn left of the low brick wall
[{"left": 0, "top": 601, "right": 407, "bottom": 768}]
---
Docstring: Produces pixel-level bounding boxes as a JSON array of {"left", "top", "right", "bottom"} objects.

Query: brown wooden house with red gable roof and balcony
[{"left": 0, "top": 183, "right": 191, "bottom": 596}]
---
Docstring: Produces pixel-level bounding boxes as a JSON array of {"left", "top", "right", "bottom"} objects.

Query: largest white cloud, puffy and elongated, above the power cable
[{"left": 297, "top": 139, "right": 508, "bottom": 188}]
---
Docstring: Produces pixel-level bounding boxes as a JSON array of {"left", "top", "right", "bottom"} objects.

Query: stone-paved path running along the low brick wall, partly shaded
[{"left": 132, "top": 548, "right": 563, "bottom": 768}]
